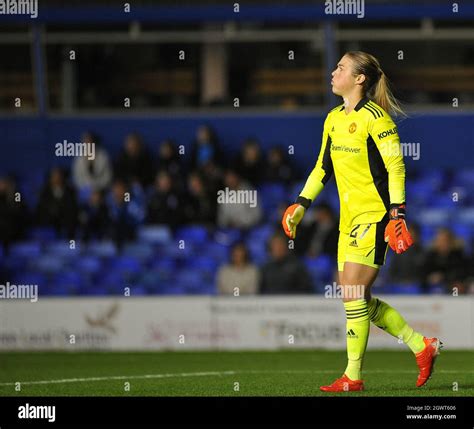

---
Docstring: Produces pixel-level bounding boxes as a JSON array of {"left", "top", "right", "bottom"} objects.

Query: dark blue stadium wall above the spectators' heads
[{"left": 0, "top": 109, "right": 474, "bottom": 175}]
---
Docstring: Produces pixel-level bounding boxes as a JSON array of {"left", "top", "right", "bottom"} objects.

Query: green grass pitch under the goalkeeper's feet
[{"left": 0, "top": 350, "right": 474, "bottom": 396}]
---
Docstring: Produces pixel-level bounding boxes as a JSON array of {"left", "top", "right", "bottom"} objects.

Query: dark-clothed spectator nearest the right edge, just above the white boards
[{"left": 425, "top": 228, "right": 468, "bottom": 293}]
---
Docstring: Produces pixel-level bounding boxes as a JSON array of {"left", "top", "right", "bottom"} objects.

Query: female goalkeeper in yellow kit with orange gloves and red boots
[{"left": 282, "top": 51, "right": 441, "bottom": 392}]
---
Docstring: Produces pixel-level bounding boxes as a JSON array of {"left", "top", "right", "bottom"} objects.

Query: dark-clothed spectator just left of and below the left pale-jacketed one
[{"left": 36, "top": 167, "right": 78, "bottom": 239}]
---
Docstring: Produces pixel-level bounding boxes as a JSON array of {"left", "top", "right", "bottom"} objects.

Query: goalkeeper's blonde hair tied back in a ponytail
[{"left": 345, "top": 51, "right": 406, "bottom": 116}]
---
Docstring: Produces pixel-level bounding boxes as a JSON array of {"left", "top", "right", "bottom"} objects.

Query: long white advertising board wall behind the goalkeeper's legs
[{"left": 0, "top": 296, "right": 474, "bottom": 351}]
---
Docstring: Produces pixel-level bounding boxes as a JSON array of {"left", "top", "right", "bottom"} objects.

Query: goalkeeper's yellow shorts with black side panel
[{"left": 337, "top": 216, "right": 388, "bottom": 271}]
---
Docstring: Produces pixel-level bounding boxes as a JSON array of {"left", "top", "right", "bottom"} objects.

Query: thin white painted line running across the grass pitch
[{"left": 0, "top": 369, "right": 474, "bottom": 386}]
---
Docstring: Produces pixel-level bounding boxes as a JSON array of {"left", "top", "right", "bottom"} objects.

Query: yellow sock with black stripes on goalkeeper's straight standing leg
[{"left": 344, "top": 299, "right": 370, "bottom": 380}]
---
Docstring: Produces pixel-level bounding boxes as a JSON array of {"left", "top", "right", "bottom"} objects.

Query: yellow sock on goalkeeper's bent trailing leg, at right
[{"left": 368, "top": 298, "right": 425, "bottom": 353}]
